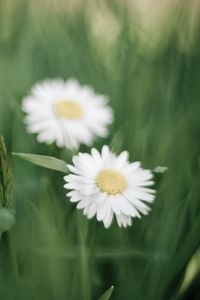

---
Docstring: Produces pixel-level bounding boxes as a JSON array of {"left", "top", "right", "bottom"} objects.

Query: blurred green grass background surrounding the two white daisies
[{"left": 0, "top": 0, "right": 200, "bottom": 300}]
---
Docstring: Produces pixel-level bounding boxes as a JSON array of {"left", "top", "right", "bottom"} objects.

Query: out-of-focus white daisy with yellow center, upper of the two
[{"left": 22, "top": 79, "right": 112, "bottom": 149}]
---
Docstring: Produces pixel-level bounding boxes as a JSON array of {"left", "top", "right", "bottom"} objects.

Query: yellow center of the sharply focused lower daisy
[{"left": 96, "top": 169, "right": 127, "bottom": 195}]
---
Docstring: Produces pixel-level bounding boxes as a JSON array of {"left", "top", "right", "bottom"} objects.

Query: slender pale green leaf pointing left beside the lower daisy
[{"left": 13, "top": 153, "right": 68, "bottom": 173}]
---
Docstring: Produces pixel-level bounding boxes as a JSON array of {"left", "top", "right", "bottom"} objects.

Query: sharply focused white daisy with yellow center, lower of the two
[{"left": 64, "top": 146, "right": 155, "bottom": 228}]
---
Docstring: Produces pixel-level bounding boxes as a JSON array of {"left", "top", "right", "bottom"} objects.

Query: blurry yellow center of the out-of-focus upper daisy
[{"left": 54, "top": 100, "right": 83, "bottom": 119}]
